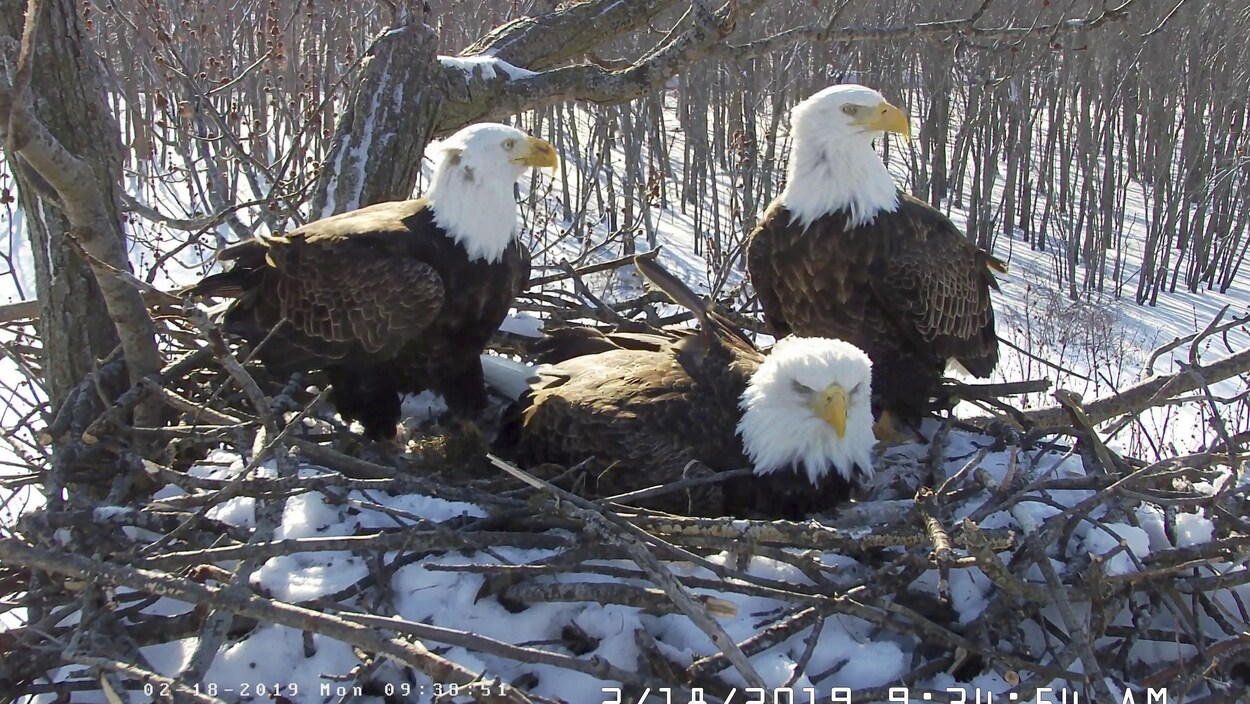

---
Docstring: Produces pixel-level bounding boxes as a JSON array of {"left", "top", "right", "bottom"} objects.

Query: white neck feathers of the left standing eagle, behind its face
[{"left": 425, "top": 153, "right": 520, "bottom": 263}]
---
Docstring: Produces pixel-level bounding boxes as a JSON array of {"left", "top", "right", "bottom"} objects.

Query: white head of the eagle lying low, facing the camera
[{"left": 738, "top": 336, "right": 876, "bottom": 484}]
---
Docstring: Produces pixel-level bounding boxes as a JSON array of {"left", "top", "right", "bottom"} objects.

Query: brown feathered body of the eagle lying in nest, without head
[{"left": 498, "top": 313, "right": 850, "bottom": 519}]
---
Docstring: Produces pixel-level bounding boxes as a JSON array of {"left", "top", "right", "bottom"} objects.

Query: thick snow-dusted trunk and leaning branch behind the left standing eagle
[{"left": 313, "top": 0, "right": 761, "bottom": 215}]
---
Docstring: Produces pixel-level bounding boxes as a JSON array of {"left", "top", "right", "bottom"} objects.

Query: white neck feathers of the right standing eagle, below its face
[{"left": 781, "top": 133, "right": 899, "bottom": 228}]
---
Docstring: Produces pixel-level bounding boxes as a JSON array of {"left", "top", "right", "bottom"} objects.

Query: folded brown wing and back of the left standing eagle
[{"left": 200, "top": 200, "right": 455, "bottom": 366}]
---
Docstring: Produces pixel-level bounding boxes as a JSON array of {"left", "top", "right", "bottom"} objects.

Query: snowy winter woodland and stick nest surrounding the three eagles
[{"left": 0, "top": 0, "right": 1250, "bottom": 704}]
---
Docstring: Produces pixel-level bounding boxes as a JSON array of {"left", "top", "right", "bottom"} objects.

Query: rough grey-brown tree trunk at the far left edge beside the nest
[{"left": 0, "top": 0, "right": 160, "bottom": 440}]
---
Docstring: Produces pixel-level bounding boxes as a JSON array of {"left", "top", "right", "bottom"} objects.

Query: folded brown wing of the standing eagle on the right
[{"left": 869, "top": 194, "right": 1001, "bottom": 376}]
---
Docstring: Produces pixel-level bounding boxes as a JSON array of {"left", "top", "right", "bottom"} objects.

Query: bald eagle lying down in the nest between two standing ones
[{"left": 488, "top": 259, "right": 875, "bottom": 518}]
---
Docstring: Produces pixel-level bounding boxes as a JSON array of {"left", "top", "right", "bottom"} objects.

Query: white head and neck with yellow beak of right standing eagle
[{"left": 781, "top": 84, "right": 910, "bottom": 226}]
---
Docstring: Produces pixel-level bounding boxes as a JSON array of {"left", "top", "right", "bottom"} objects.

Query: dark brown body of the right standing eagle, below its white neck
[{"left": 746, "top": 191, "right": 1005, "bottom": 418}]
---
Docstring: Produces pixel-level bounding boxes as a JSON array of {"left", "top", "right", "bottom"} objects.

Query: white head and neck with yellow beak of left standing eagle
[{"left": 425, "top": 123, "right": 559, "bottom": 261}]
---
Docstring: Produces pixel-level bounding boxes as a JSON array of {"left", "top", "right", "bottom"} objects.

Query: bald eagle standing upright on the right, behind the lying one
[{"left": 746, "top": 85, "right": 1006, "bottom": 433}]
